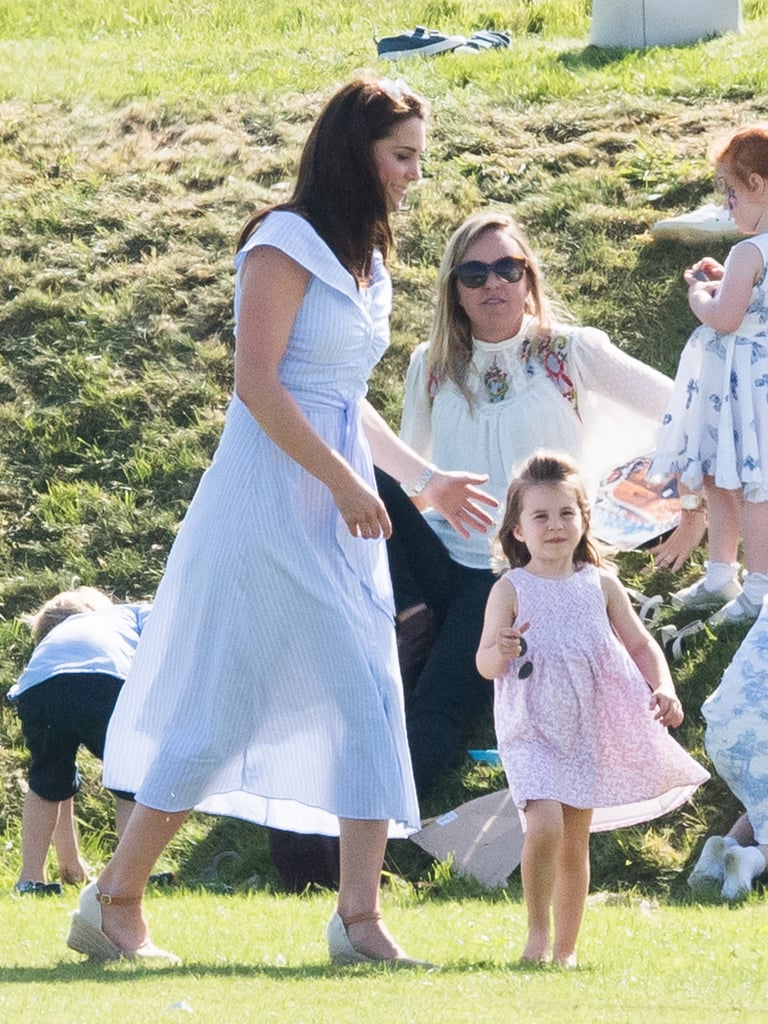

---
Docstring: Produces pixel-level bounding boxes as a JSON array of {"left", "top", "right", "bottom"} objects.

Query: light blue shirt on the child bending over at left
[{"left": 8, "top": 604, "right": 152, "bottom": 700}]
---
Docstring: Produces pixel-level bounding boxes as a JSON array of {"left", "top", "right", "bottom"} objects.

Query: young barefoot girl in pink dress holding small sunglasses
[{"left": 477, "top": 452, "right": 709, "bottom": 966}]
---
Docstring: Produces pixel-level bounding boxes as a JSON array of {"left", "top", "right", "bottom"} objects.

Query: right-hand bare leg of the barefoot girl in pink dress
[{"left": 552, "top": 804, "right": 592, "bottom": 964}]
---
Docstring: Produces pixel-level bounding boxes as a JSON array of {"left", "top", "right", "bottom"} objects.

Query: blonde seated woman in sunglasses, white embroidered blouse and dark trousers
[{"left": 378, "top": 212, "right": 703, "bottom": 799}]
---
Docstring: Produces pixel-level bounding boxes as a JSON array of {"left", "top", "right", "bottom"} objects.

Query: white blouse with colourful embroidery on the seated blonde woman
[{"left": 400, "top": 317, "right": 672, "bottom": 568}]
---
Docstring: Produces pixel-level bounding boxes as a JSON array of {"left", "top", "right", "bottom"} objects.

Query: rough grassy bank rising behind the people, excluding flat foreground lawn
[{"left": 0, "top": 0, "right": 768, "bottom": 886}]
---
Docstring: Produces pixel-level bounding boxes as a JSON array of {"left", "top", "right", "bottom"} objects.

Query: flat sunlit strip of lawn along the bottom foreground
[{"left": 0, "top": 893, "right": 768, "bottom": 1024}]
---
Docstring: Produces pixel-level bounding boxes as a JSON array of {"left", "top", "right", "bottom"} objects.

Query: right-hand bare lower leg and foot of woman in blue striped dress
[{"left": 337, "top": 818, "right": 404, "bottom": 959}]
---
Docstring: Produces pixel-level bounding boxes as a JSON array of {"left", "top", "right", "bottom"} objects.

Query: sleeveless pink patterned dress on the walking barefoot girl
[{"left": 495, "top": 565, "right": 709, "bottom": 831}]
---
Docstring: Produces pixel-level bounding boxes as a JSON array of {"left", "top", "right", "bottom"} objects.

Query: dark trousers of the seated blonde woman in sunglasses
[{"left": 376, "top": 469, "right": 497, "bottom": 800}]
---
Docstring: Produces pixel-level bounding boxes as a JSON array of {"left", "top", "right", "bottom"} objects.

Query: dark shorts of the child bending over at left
[{"left": 15, "top": 672, "right": 123, "bottom": 802}]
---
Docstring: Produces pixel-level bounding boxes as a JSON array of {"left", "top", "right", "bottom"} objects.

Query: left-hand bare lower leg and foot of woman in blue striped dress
[{"left": 98, "top": 804, "right": 188, "bottom": 950}]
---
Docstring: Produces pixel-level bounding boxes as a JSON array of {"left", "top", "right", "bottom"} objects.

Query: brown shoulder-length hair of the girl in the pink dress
[{"left": 498, "top": 450, "right": 604, "bottom": 568}]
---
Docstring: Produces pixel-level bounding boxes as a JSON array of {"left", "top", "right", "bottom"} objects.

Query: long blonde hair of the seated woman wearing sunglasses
[{"left": 427, "top": 211, "right": 559, "bottom": 404}]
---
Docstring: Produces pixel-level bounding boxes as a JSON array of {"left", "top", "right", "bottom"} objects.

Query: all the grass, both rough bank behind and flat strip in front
[{"left": 0, "top": 6, "right": 768, "bottom": 1022}]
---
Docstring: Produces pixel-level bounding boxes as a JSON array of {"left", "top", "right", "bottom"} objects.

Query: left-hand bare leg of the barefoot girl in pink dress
[{"left": 520, "top": 800, "right": 563, "bottom": 963}]
